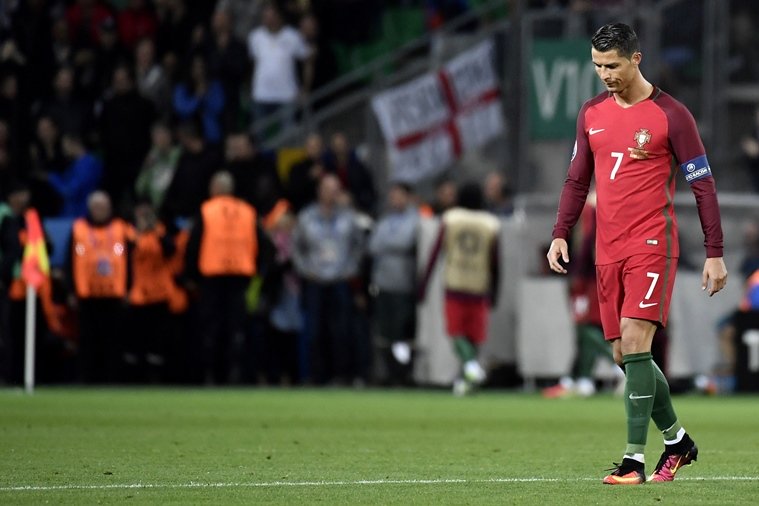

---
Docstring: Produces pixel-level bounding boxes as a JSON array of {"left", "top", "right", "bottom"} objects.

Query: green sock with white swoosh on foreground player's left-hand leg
[{"left": 622, "top": 352, "right": 656, "bottom": 446}]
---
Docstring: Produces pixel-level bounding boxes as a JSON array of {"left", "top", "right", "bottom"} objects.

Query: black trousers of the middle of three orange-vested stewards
[{"left": 124, "top": 303, "right": 169, "bottom": 383}]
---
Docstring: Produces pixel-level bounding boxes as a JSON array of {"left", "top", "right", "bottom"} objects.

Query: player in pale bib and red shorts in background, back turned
[{"left": 418, "top": 182, "right": 500, "bottom": 395}]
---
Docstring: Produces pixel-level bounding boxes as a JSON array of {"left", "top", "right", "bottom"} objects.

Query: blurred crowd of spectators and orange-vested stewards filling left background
[{"left": 0, "top": 0, "right": 510, "bottom": 384}]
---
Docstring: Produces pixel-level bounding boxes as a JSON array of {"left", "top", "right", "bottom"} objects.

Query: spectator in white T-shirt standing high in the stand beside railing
[{"left": 248, "top": 4, "right": 314, "bottom": 132}]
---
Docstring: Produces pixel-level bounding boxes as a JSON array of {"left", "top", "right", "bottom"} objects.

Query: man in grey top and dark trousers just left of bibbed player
[{"left": 369, "top": 182, "right": 420, "bottom": 385}]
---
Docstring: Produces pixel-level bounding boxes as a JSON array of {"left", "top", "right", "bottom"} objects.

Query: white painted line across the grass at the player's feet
[{"left": 0, "top": 476, "right": 759, "bottom": 492}]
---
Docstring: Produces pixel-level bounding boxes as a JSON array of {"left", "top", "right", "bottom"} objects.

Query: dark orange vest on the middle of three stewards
[{"left": 129, "top": 224, "right": 173, "bottom": 306}]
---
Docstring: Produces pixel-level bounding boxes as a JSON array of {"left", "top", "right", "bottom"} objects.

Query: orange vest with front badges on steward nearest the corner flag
[{"left": 71, "top": 218, "right": 130, "bottom": 299}]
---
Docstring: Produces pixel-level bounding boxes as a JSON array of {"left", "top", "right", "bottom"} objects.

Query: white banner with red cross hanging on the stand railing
[{"left": 372, "top": 41, "right": 503, "bottom": 183}]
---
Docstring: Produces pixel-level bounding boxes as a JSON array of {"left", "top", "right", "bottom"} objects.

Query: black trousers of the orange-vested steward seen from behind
[{"left": 198, "top": 276, "right": 250, "bottom": 383}]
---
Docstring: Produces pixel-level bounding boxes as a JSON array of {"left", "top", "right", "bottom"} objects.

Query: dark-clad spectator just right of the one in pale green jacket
[{"left": 161, "top": 122, "right": 223, "bottom": 224}]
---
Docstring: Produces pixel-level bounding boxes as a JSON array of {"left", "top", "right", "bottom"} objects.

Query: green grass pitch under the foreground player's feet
[{"left": 0, "top": 389, "right": 759, "bottom": 506}]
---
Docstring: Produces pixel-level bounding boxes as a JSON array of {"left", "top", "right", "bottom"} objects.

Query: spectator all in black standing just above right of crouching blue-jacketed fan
[{"left": 98, "top": 65, "right": 155, "bottom": 210}]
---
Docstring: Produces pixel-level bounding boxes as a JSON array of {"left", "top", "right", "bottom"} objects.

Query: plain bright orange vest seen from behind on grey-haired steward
[{"left": 198, "top": 195, "right": 258, "bottom": 276}]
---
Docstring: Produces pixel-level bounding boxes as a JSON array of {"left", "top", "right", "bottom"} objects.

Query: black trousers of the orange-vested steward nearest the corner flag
[{"left": 79, "top": 298, "right": 126, "bottom": 383}]
